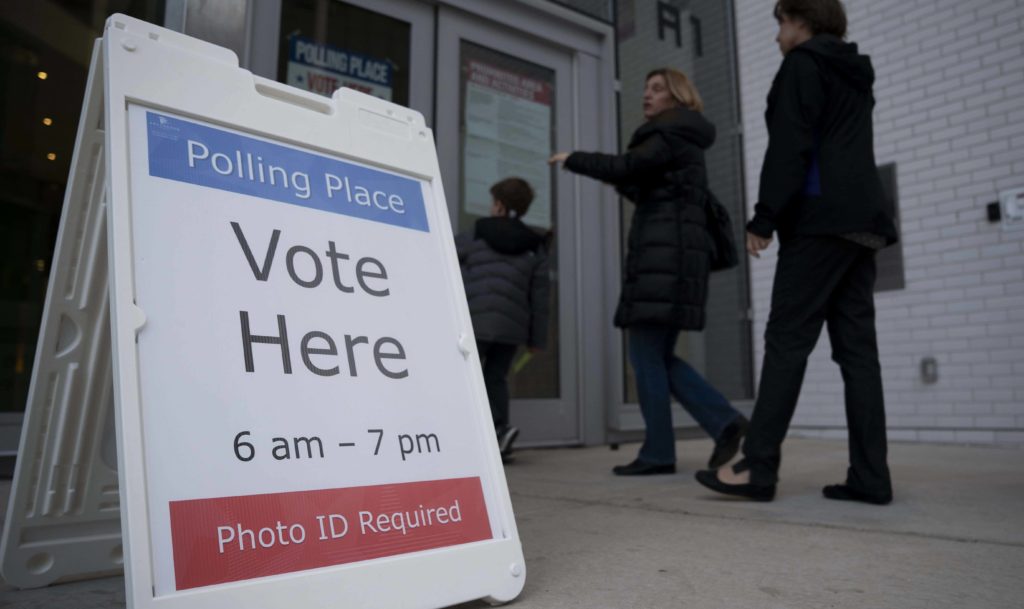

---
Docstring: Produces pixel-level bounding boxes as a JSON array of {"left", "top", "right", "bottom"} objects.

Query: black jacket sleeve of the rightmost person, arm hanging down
[{"left": 746, "top": 50, "right": 825, "bottom": 237}]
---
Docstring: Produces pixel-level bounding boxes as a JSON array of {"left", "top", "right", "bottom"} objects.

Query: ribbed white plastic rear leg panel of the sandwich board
[{"left": 0, "top": 41, "right": 122, "bottom": 588}]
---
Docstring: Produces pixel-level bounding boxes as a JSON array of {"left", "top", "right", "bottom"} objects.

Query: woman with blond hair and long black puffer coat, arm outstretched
[{"left": 550, "top": 68, "right": 746, "bottom": 476}]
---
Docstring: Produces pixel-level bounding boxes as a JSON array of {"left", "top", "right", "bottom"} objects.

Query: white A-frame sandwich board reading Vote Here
[{"left": 2, "top": 15, "right": 525, "bottom": 609}]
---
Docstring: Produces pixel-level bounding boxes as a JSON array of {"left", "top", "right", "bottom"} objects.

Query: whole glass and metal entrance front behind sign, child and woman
[{"left": 0, "top": 0, "right": 753, "bottom": 458}]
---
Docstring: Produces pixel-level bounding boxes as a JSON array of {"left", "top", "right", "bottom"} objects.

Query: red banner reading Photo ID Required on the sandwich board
[{"left": 170, "top": 478, "right": 492, "bottom": 590}]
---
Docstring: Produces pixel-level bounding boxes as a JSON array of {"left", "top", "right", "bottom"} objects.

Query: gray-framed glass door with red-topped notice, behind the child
[{"left": 435, "top": 6, "right": 582, "bottom": 445}]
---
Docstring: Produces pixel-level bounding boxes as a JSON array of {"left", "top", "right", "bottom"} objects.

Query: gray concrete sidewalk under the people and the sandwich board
[{"left": 0, "top": 439, "right": 1024, "bottom": 609}]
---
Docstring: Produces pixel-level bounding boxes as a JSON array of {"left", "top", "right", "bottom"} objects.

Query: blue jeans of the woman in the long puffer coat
[{"left": 629, "top": 325, "right": 739, "bottom": 465}]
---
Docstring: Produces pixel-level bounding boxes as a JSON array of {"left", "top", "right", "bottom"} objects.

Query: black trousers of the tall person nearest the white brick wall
[{"left": 743, "top": 236, "right": 892, "bottom": 494}]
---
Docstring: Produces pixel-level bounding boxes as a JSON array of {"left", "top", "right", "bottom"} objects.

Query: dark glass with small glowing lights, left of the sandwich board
[{"left": 0, "top": 0, "right": 164, "bottom": 415}]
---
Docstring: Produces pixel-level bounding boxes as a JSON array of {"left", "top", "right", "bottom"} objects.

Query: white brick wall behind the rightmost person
[{"left": 735, "top": 0, "right": 1024, "bottom": 444}]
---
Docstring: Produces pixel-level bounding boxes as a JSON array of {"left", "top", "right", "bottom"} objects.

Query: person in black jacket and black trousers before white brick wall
[{"left": 696, "top": 0, "right": 896, "bottom": 505}]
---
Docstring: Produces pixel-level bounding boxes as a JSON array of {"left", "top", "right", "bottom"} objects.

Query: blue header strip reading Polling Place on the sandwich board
[{"left": 146, "top": 112, "right": 430, "bottom": 232}]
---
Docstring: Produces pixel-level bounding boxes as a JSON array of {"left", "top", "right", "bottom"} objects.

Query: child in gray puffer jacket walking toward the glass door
[{"left": 455, "top": 177, "right": 549, "bottom": 461}]
